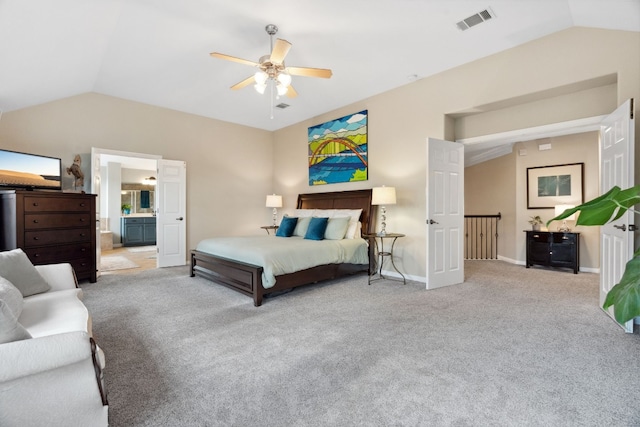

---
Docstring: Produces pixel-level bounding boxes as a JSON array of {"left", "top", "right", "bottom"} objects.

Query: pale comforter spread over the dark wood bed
[{"left": 196, "top": 236, "right": 369, "bottom": 289}]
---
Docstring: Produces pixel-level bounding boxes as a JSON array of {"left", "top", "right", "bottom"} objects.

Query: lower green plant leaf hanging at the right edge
[{"left": 602, "top": 251, "right": 640, "bottom": 323}]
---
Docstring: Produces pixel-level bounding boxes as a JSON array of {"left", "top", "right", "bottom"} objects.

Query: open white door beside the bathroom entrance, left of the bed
[{"left": 156, "top": 159, "right": 187, "bottom": 267}]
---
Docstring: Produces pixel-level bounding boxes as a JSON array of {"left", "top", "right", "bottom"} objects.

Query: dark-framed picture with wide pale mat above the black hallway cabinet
[{"left": 527, "top": 163, "right": 584, "bottom": 209}]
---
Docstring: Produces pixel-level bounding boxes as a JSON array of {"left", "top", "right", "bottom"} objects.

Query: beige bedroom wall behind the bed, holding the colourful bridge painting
[{"left": 274, "top": 28, "right": 640, "bottom": 278}]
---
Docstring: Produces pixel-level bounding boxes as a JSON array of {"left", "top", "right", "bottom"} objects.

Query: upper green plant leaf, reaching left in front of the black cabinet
[{"left": 547, "top": 185, "right": 640, "bottom": 227}]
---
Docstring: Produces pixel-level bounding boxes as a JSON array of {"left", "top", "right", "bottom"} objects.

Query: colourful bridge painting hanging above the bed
[{"left": 307, "top": 110, "right": 369, "bottom": 186}]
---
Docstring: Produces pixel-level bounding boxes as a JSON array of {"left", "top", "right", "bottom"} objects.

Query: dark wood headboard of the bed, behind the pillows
[{"left": 297, "top": 189, "right": 375, "bottom": 234}]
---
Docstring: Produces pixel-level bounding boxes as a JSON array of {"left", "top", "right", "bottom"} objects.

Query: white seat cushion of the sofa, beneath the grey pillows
[{"left": 18, "top": 289, "right": 91, "bottom": 338}]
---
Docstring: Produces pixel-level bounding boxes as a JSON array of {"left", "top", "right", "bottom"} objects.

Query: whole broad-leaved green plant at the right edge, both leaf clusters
[{"left": 547, "top": 185, "right": 640, "bottom": 323}]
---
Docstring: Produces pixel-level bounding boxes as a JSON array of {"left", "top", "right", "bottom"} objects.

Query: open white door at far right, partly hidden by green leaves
[{"left": 600, "top": 99, "right": 634, "bottom": 333}]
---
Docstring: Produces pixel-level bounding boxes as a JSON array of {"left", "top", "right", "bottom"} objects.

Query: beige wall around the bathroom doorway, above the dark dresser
[{"left": 0, "top": 93, "right": 274, "bottom": 248}]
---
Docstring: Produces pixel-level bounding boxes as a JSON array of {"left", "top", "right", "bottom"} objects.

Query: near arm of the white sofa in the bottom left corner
[{"left": 0, "top": 332, "right": 108, "bottom": 426}]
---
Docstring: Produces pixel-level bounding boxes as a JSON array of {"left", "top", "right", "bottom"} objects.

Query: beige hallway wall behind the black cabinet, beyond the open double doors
[{"left": 465, "top": 132, "right": 600, "bottom": 271}]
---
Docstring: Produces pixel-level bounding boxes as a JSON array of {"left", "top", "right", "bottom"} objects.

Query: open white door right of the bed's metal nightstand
[{"left": 427, "top": 138, "right": 464, "bottom": 289}]
